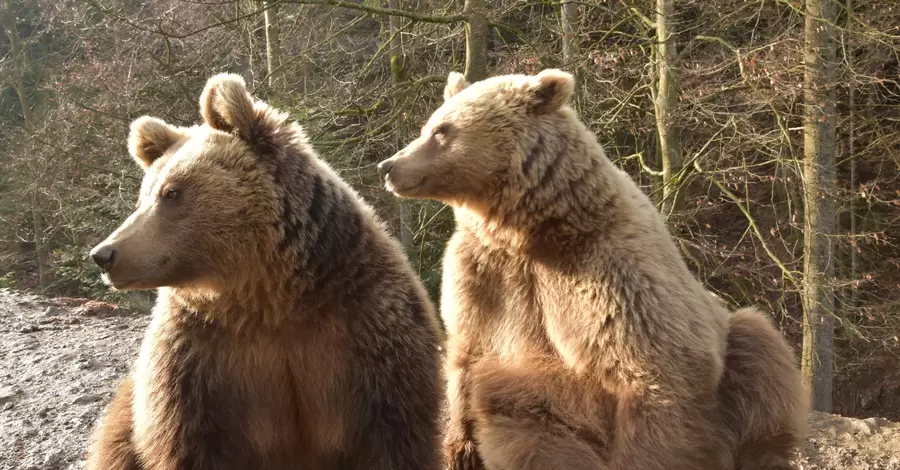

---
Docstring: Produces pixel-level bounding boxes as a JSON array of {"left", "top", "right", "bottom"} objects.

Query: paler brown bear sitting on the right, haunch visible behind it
[{"left": 379, "top": 69, "right": 807, "bottom": 470}]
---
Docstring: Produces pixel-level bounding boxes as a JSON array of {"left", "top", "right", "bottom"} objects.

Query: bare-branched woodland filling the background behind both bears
[{"left": 0, "top": 0, "right": 900, "bottom": 420}]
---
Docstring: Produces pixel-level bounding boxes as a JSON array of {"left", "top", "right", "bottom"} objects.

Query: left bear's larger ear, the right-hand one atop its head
[{"left": 200, "top": 73, "right": 255, "bottom": 140}]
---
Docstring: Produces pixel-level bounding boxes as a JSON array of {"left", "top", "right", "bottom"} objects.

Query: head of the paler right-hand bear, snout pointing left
[{"left": 378, "top": 69, "right": 574, "bottom": 209}]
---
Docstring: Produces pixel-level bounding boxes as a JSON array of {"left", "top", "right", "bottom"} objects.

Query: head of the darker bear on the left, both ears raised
[{"left": 91, "top": 74, "right": 280, "bottom": 290}]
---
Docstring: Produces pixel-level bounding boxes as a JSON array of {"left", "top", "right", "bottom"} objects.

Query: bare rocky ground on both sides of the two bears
[{"left": 0, "top": 289, "right": 900, "bottom": 470}]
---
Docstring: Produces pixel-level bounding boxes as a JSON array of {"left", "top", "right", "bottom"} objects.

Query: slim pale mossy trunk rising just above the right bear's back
[{"left": 655, "top": 0, "right": 683, "bottom": 215}]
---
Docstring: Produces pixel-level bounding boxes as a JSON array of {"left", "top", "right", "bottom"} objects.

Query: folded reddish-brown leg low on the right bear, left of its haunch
[{"left": 471, "top": 357, "right": 614, "bottom": 470}]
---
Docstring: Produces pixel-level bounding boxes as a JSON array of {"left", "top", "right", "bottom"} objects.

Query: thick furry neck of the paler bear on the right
[{"left": 455, "top": 119, "right": 624, "bottom": 255}]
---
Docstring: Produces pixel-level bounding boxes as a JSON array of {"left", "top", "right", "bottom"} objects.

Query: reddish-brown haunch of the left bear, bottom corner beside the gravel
[{"left": 85, "top": 375, "right": 143, "bottom": 470}]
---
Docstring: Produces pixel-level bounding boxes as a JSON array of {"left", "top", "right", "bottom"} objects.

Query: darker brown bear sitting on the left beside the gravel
[{"left": 87, "top": 74, "right": 444, "bottom": 470}]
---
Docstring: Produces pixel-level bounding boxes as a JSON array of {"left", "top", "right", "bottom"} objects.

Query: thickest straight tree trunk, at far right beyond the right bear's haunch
[{"left": 802, "top": 0, "right": 836, "bottom": 412}]
